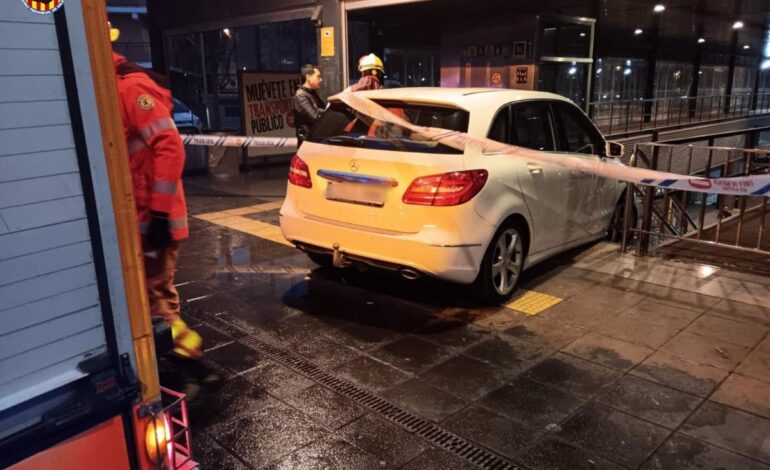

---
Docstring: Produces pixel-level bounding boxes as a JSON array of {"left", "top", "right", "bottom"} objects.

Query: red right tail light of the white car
[{"left": 403, "top": 170, "right": 489, "bottom": 206}]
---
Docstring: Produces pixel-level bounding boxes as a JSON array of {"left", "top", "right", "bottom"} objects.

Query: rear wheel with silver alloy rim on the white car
[{"left": 474, "top": 220, "right": 529, "bottom": 304}]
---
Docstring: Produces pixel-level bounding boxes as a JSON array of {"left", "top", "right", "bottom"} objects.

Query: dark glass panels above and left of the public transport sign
[{"left": 166, "top": 20, "right": 318, "bottom": 132}]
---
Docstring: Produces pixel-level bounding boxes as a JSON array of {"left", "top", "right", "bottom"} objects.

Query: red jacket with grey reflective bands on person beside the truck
[{"left": 112, "top": 52, "right": 189, "bottom": 240}]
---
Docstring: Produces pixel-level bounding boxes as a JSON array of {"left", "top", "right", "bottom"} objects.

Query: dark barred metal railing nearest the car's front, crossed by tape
[{"left": 622, "top": 143, "right": 770, "bottom": 256}]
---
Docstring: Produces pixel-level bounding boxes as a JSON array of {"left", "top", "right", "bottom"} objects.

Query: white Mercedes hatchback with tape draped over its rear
[{"left": 280, "top": 88, "right": 625, "bottom": 303}]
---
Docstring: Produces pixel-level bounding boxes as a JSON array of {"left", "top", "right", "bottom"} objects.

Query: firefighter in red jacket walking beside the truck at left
[{"left": 110, "top": 24, "right": 212, "bottom": 392}]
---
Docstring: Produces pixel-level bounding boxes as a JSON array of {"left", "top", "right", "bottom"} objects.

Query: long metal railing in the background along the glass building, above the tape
[{"left": 588, "top": 93, "right": 770, "bottom": 134}]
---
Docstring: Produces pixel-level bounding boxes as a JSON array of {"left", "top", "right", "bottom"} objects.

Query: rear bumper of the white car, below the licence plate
[{"left": 280, "top": 198, "right": 495, "bottom": 284}]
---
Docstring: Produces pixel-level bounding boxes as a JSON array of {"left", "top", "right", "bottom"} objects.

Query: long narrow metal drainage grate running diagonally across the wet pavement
[{"left": 184, "top": 305, "right": 519, "bottom": 470}]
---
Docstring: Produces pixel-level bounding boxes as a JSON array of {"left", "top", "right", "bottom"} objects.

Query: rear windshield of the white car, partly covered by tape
[{"left": 307, "top": 101, "right": 468, "bottom": 154}]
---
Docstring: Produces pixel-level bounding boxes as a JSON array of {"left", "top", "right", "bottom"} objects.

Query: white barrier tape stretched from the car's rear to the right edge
[{"left": 332, "top": 88, "right": 770, "bottom": 196}]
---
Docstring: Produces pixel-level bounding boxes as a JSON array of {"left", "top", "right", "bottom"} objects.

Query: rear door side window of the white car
[{"left": 510, "top": 101, "right": 554, "bottom": 151}]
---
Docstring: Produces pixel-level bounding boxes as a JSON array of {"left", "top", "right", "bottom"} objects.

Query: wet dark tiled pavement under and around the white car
[{"left": 176, "top": 172, "right": 770, "bottom": 470}]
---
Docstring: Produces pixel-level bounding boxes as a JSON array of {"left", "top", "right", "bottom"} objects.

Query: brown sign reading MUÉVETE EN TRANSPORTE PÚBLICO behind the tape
[{"left": 239, "top": 71, "right": 300, "bottom": 157}]
